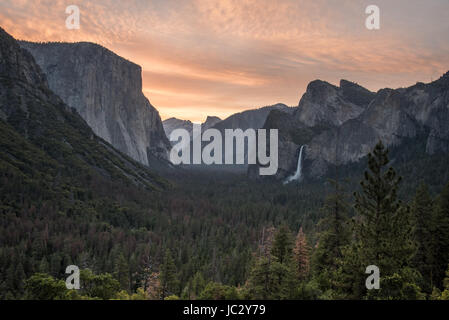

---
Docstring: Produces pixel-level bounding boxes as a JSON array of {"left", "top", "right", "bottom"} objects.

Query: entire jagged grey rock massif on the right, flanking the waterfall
[{"left": 256, "top": 72, "right": 449, "bottom": 179}]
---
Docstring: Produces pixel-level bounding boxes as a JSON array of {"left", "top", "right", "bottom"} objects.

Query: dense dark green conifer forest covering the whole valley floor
[{"left": 0, "top": 143, "right": 449, "bottom": 299}]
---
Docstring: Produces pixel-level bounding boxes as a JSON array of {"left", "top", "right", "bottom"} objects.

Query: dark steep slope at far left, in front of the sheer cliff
[{"left": 0, "top": 27, "right": 165, "bottom": 189}]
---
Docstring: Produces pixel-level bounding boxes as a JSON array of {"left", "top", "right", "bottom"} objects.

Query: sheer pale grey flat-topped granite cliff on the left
[{"left": 20, "top": 42, "right": 170, "bottom": 167}]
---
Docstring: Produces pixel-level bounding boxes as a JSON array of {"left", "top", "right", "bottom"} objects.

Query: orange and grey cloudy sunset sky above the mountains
[{"left": 0, "top": 0, "right": 449, "bottom": 122}]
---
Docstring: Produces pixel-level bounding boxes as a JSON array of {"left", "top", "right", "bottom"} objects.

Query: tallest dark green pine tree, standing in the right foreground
[{"left": 353, "top": 141, "right": 419, "bottom": 299}]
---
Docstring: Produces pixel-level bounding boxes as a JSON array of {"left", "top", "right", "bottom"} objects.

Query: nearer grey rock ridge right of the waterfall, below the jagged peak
[{"left": 307, "top": 75, "right": 449, "bottom": 178}]
